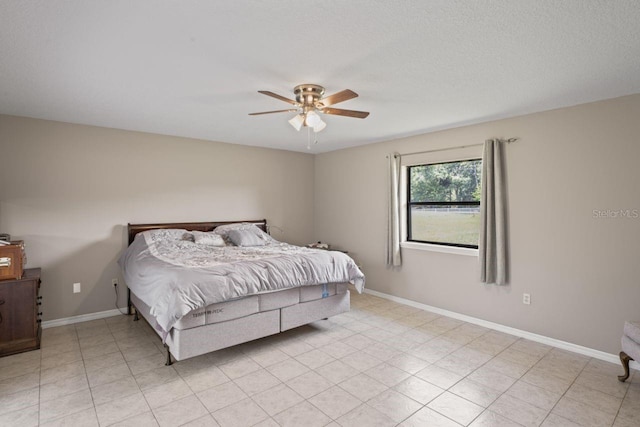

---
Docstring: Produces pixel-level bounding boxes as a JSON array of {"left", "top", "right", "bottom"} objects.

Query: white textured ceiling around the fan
[{"left": 0, "top": 0, "right": 640, "bottom": 153}]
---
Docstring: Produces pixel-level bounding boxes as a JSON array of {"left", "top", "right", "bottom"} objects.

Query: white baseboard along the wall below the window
[{"left": 364, "top": 289, "right": 640, "bottom": 370}]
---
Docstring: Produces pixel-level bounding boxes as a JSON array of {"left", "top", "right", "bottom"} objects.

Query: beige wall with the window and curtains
[{"left": 314, "top": 95, "right": 640, "bottom": 353}]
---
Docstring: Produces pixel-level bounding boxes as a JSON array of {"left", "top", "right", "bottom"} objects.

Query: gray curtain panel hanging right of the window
[{"left": 478, "top": 139, "right": 508, "bottom": 285}]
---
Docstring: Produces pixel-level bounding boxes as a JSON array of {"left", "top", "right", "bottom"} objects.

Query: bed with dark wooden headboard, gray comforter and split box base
[{"left": 118, "top": 219, "right": 364, "bottom": 365}]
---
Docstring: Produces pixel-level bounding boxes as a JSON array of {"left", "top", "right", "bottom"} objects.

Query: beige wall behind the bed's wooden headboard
[{"left": 0, "top": 115, "right": 314, "bottom": 320}]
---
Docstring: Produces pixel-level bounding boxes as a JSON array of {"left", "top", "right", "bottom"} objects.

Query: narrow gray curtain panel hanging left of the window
[{"left": 387, "top": 153, "right": 402, "bottom": 267}]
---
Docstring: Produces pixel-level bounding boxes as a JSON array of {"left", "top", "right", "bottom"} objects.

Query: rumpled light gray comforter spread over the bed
[{"left": 118, "top": 230, "right": 364, "bottom": 338}]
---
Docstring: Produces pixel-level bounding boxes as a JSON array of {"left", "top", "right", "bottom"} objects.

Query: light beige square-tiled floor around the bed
[{"left": 0, "top": 293, "right": 640, "bottom": 427}]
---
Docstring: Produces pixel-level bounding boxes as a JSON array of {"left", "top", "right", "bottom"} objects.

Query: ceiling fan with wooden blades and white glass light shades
[{"left": 249, "top": 83, "right": 369, "bottom": 132}]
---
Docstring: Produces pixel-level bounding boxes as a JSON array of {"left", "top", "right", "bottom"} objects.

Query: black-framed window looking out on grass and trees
[{"left": 407, "top": 159, "right": 482, "bottom": 249}]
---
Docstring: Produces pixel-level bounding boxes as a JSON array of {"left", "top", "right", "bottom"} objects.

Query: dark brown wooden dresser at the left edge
[{"left": 0, "top": 268, "right": 42, "bottom": 356}]
